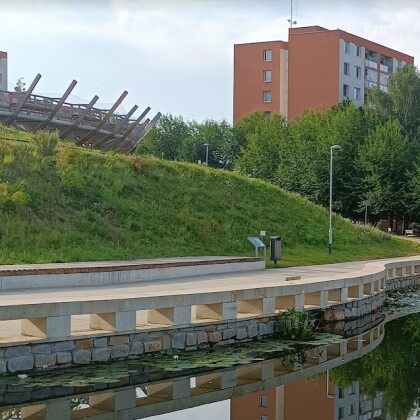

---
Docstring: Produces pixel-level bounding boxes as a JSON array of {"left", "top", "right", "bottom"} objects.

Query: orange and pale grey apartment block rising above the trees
[{"left": 233, "top": 26, "right": 414, "bottom": 122}]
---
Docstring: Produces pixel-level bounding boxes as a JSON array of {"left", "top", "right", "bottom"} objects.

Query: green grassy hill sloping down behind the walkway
[{"left": 0, "top": 126, "right": 420, "bottom": 266}]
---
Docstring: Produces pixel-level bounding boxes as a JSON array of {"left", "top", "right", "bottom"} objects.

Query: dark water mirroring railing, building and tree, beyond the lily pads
[{"left": 0, "top": 315, "right": 420, "bottom": 420}]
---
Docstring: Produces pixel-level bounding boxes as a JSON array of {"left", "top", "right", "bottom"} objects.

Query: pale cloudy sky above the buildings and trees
[{"left": 0, "top": 0, "right": 420, "bottom": 122}]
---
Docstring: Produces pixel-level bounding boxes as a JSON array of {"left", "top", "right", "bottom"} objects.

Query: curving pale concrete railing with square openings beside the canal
[{"left": 0, "top": 260, "right": 420, "bottom": 345}]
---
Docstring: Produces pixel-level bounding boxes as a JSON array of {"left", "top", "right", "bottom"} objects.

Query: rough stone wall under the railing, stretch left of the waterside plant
[{"left": 0, "top": 316, "right": 276, "bottom": 374}]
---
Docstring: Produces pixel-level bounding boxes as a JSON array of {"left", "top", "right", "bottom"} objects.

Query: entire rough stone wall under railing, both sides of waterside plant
[{"left": 0, "top": 275, "right": 420, "bottom": 374}]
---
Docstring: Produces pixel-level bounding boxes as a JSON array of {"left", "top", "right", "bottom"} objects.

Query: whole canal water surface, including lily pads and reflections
[{"left": 0, "top": 313, "right": 420, "bottom": 420}]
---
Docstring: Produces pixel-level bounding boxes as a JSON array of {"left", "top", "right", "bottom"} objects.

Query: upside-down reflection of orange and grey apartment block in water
[{"left": 230, "top": 376, "right": 382, "bottom": 420}]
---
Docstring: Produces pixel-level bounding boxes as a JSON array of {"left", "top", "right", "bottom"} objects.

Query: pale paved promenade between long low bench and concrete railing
[{"left": 0, "top": 256, "right": 419, "bottom": 307}]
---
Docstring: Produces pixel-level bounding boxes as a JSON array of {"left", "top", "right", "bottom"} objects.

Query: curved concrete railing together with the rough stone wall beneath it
[{"left": 0, "top": 257, "right": 420, "bottom": 374}]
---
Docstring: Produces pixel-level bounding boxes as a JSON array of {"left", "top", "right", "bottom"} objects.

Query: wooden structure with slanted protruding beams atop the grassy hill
[{"left": 0, "top": 74, "right": 161, "bottom": 153}]
